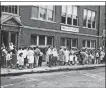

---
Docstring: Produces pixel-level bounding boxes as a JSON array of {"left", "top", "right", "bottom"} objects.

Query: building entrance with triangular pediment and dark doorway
[{"left": 0, "top": 14, "right": 23, "bottom": 48}]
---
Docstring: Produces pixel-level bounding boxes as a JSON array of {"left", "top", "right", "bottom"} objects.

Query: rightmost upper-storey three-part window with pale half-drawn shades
[{"left": 83, "top": 9, "right": 96, "bottom": 28}]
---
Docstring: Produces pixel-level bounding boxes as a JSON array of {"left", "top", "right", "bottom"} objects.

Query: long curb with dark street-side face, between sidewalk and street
[{"left": 0, "top": 64, "right": 106, "bottom": 76}]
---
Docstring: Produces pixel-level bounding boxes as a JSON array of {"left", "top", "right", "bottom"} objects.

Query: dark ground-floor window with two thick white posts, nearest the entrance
[{"left": 31, "top": 34, "right": 53, "bottom": 46}]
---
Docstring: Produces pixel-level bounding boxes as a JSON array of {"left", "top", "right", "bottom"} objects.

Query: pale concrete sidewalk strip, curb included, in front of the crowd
[{"left": 1, "top": 64, "right": 105, "bottom": 76}]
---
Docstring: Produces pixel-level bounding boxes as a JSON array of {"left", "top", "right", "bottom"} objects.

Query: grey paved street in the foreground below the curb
[{"left": 1, "top": 67, "right": 105, "bottom": 88}]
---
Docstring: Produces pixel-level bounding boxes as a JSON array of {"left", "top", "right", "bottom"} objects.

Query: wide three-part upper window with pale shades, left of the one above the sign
[{"left": 31, "top": 5, "right": 54, "bottom": 21}]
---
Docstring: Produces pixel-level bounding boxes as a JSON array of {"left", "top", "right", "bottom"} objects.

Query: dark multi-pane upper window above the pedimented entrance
[{"left": 1, "top": 5, "right": 18, "bottom": 14}]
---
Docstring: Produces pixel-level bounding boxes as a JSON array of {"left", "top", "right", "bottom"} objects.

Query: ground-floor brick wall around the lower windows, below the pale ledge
[{"left": 19, "top": 28, "right": 100, "bottom": 49}]
